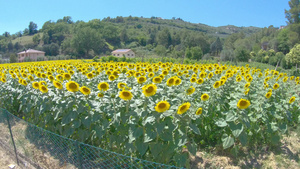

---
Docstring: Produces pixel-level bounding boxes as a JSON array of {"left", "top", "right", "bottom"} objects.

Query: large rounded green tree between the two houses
[{"left": 71, "top": 27, "right": 105, "bottom": 57}]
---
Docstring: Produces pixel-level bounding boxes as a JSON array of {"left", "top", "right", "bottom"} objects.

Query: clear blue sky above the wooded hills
[{"left": 0, "top": 0, "right": 289, "bottom": 34}]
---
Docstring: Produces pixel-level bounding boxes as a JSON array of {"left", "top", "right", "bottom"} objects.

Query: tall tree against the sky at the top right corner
[{"left": 285, "top": 0, "right": 300, "bottom": 24}]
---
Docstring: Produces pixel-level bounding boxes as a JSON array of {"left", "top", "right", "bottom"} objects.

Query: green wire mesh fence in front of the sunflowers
[{"left": 0, "top": 109, "right": 182, "bottom": 169}]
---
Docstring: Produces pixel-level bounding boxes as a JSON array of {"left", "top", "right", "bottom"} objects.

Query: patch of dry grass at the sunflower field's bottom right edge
[{"left": 191, "top": 127, "right": 300, "bottom": 169}]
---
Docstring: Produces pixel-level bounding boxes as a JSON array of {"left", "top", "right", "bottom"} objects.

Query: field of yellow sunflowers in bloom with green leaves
[{"left": 0, "top": 60, "right": 300, "bottom": 167}]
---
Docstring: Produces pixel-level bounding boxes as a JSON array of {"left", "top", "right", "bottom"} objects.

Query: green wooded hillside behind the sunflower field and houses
[{"left": 0, "top": 13, "right": 300, "bottom": 66}]
